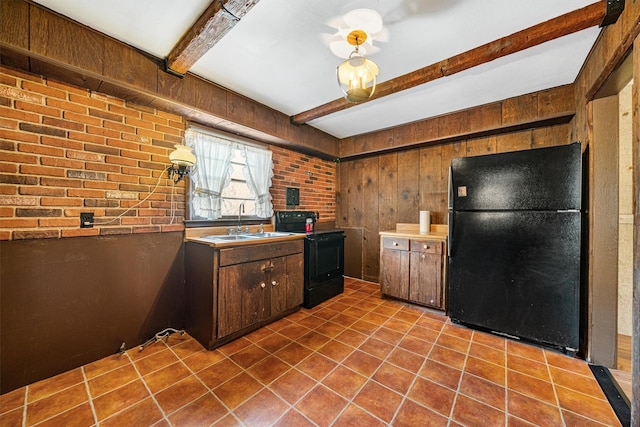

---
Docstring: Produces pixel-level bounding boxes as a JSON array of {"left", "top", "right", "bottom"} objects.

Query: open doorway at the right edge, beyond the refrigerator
[{"left": 588, "top": 51, "right": 634, "bottom": 398}]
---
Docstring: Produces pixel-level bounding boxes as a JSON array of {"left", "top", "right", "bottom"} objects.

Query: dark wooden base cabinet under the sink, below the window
[{"left": 186, "top": 241, "right": 304, "bottom": 349}]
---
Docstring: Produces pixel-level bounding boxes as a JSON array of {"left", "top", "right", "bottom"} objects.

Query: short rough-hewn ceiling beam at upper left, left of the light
[{"left": 165, "top": 0, "right": 260, "bottom": 76}]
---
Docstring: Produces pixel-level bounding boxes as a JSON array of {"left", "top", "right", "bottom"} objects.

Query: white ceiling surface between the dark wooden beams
[{"left": 35, "top": 0, "right": 600, "bottom": 138}]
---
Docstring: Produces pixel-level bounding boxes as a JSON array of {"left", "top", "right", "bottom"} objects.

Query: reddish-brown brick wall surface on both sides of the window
[{"left": 0, "top": 67, "right": 336, "bottom": 240}]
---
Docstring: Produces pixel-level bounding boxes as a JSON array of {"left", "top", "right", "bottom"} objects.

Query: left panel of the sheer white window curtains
[{"left": 185, "top": 130, "right": 233, "bottom": 219}]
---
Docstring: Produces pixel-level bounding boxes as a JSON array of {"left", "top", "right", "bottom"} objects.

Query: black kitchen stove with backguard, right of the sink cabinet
[{"left": 275, "top": 211, "right": 345, "bottom": 308}]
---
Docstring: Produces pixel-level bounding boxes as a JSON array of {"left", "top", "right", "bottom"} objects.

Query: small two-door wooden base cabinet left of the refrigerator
[{"left": 380, "top": 237, "right": 445, "bottom": 310}]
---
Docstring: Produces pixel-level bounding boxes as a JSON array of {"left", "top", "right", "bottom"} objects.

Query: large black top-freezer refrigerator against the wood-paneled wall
[{"left": 448, "top": 143, "right": 584, "bottom": 354}]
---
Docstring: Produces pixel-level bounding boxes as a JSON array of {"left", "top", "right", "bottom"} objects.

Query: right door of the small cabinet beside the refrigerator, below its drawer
[{"left": 409, "top": 252, "right": 442, "bottom": 308}]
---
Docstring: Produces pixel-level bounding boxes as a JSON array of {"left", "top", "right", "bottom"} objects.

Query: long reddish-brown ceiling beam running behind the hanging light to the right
[{"left": 290, "top": 0, "right": 607, "bottom": 125}]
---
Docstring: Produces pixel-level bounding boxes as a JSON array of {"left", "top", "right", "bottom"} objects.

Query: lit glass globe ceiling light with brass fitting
[{"left": 336, "top": 30, "right": 378, "bottom": 102}]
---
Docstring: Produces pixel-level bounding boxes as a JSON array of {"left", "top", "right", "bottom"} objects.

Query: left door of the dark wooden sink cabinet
[{"left": 218, "top": 261, "right": 270, "bottom": 337}]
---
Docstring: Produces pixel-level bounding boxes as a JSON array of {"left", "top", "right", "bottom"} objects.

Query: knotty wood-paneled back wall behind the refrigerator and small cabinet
[{"left": 336, "top": 124, "right": 572, "bottom": 282}]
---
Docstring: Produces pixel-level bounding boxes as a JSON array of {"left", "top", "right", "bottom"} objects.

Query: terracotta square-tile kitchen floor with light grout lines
[{"left": 0, "top": 279, "right": 619, "bottom": 426}]
